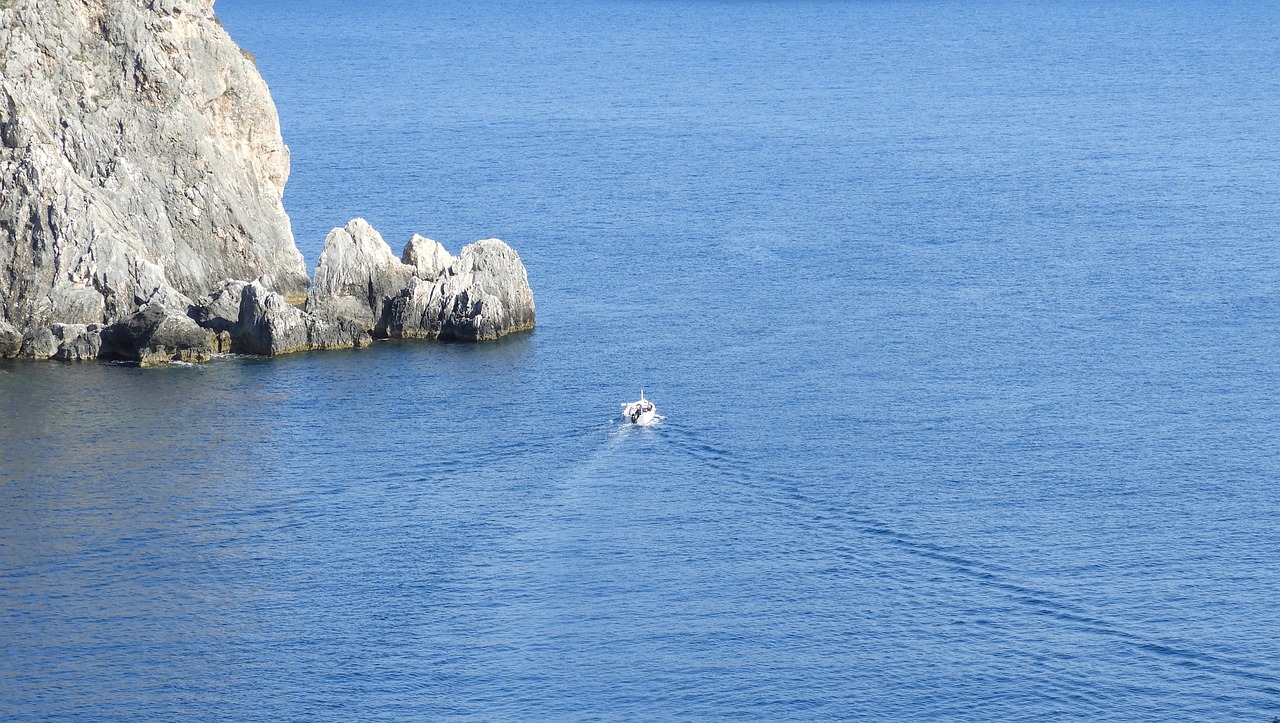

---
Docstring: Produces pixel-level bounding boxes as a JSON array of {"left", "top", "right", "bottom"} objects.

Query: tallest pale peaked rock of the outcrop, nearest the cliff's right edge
[{"left": 306, "top": 219, "right": 413, "bottom": 330}]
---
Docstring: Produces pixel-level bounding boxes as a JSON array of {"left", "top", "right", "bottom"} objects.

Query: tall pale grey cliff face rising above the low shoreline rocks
[{"left": 0, "top": 0, "right": 307, "bottom": 332}]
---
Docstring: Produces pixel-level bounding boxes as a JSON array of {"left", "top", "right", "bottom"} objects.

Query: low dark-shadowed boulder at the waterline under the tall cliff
[{"left": 101, "top": 303, "right": 216, "bottom": 366}]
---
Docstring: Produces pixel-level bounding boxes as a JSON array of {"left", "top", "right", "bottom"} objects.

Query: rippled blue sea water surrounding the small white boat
[{"left": 0, "top": 0, "right": 1280, "bottom": 720}]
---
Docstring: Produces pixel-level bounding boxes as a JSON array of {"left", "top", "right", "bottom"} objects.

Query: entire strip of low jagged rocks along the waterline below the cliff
[{"left": 0, "top": 213, "right": 535, "bottom": 366}]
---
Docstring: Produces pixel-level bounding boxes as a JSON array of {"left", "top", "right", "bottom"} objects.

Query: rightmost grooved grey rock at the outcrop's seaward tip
[{"left": 387, "top": 238, "right": 536, "bottom": 342}]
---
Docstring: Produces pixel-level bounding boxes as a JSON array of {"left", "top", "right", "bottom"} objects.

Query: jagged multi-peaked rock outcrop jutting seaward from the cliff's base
[{"left": 180, "top": 219, "right": 535, "bottom": 354}]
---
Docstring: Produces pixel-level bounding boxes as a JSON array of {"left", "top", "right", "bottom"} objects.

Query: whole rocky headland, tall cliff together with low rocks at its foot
[{"left": 0, "top": 0, "right": 532, "bottom": 363}]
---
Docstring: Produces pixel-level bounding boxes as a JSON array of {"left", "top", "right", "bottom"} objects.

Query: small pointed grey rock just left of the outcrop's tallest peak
[{"left": 233, "top": 282, "right": 372, "bottom": 356}]
